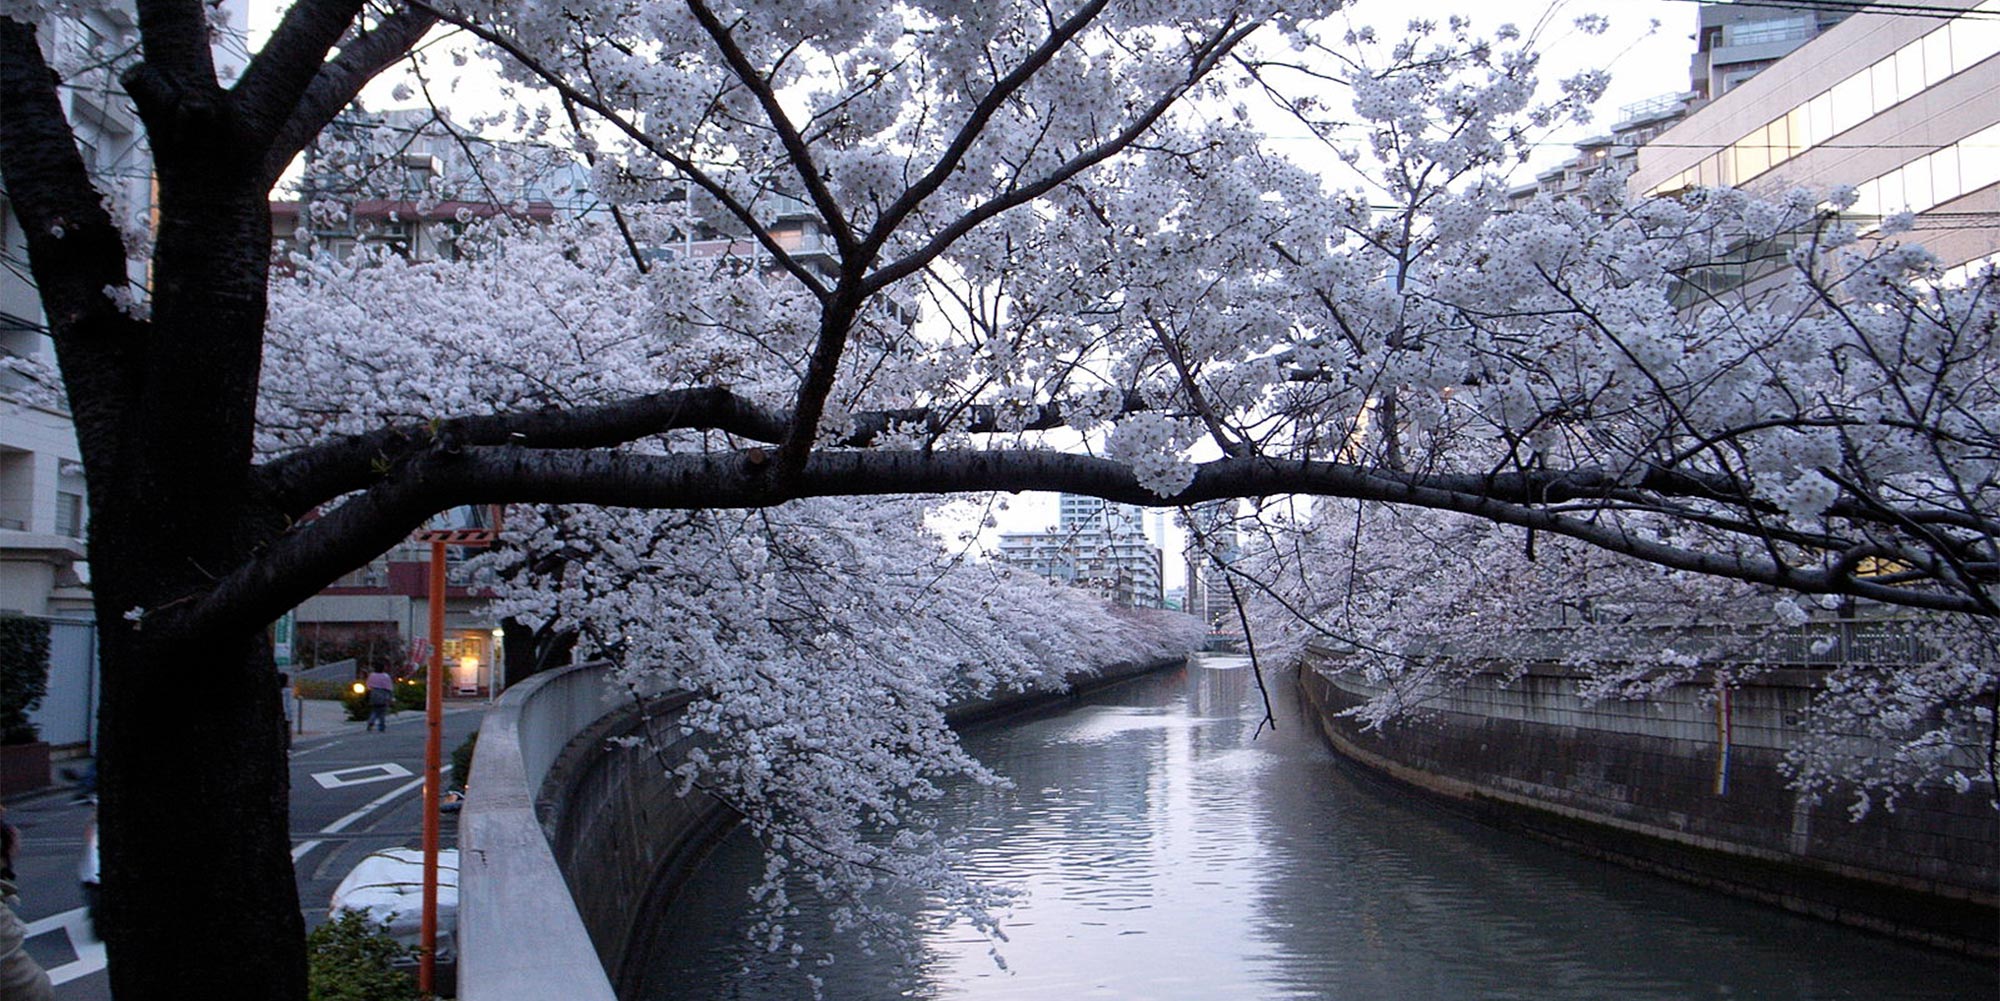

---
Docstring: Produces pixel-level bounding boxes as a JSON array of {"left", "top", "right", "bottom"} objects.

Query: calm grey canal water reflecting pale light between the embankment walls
[{"left": 640, "top": 657, "right": 2000, "bottom": 1001}]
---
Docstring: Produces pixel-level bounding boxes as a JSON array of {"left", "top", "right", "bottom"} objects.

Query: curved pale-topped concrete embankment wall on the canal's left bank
[{"left": 458, "top": 657, "right": 1184, "bottom": 1001}]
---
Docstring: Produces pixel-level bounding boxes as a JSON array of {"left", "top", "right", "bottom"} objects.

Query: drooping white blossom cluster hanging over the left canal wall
[{"left": 482, "top": 501, "right": 1200, "bottom": 947}]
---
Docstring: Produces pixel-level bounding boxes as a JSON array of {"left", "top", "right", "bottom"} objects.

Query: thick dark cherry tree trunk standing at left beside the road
[{"left": 73, "top": 116, "right": 306, "bottom": 1001}]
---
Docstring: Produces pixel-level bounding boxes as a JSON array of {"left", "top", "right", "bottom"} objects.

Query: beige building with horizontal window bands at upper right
[{"left": 1628, "top": 0, "right": 2000, "bottom": 282}]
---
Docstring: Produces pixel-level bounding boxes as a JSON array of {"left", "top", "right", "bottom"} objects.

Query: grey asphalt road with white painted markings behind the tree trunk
[{"left": 6, "top": 703, "right": 486, "bottom": 1001}]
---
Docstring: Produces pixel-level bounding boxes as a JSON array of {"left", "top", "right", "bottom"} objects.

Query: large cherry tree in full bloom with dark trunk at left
[{"left": 0, "top": 0, "right": 1996, "bottom": 999}]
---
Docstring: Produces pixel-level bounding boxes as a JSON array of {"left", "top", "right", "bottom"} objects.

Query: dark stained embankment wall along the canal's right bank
[{"left": 1298, "top": 655, "right": 2000, "bottom": 957}]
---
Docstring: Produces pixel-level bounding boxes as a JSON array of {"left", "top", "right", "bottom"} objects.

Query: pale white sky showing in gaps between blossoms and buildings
[{"left": 250, "top": 0, "right": 1698, "bottom": 589}]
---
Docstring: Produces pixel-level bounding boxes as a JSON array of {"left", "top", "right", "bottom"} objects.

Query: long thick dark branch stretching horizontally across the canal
[{"left": 195, "top": 446, "right": 1990, "bottom": 631}]
